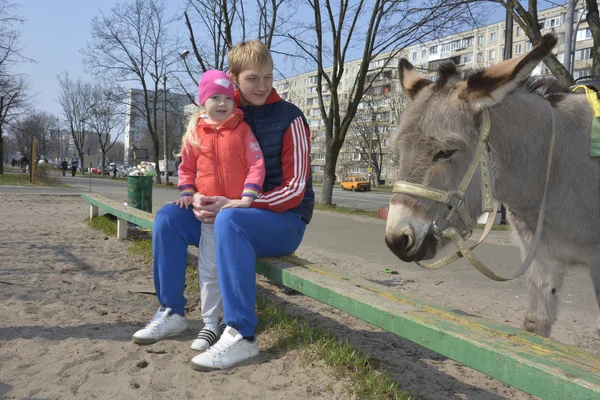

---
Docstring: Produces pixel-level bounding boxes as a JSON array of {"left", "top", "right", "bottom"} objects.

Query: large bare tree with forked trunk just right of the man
[{"left": 288, "top": 0, "right": 482, "bottom": 205}]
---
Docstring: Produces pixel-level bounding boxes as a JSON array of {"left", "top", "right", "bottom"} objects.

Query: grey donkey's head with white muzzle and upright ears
[{"left": 385, "top": 35, "right": 556, "bottom": 262}]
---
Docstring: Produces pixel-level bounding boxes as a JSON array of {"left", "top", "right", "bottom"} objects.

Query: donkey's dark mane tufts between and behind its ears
[{"left": 434, "top": 61, "right": 570, "bottom": 106}]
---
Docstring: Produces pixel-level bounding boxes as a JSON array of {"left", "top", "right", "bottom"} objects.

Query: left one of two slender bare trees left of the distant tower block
[{"left": 58, "top": 72, "right": 92, "bottom": 173}]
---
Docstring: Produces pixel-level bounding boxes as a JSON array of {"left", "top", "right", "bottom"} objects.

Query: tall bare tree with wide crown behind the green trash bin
[{"left": 83, "top": 0, "right": 178, "bottom": 183}]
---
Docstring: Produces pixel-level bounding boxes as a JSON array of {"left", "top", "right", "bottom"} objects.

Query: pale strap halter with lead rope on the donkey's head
[{"left": 392, "top": 107, "right": 556, "bottom": 281}]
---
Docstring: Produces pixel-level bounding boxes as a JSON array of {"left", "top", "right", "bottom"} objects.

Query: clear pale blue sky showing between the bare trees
[{"left": 12, "top": 0, "right": 548, "bottom": 115}]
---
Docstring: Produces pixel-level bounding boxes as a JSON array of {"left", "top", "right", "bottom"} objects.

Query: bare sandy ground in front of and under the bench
[{"left": 0, "top": 195, "right": 576, "bottom": 400}]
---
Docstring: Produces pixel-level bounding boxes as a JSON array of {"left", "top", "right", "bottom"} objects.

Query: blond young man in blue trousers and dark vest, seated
[{"left": 133, "top": 41, "right": 314, "bottom": 370}]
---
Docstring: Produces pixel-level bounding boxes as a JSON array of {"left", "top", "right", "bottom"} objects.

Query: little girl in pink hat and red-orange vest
[{"left": 133, "top": 70, "right": 265, "bottom": 351}]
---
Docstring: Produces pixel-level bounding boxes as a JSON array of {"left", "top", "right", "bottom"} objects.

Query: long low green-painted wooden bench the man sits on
[{"left": 81, "top": 194, "right": 600, "bottom": 400}]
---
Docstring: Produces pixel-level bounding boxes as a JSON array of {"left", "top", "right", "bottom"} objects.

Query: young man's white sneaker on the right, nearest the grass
[{"left": 192, "top": 326, "right": 258, "bottom": 371}]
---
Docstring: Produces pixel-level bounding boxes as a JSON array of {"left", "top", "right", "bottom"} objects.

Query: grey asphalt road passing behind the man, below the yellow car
[{"left": 50, "top": 175, "right": 390, "bottom": 210}]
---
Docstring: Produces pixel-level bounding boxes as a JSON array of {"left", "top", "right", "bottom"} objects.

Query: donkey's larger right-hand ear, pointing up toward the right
[{"left": 459, "top": 33, "right": 557, "bottom": 107}]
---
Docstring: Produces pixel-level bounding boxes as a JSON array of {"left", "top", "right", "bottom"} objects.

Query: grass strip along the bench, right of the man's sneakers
[{"left": 257, "top": 297, "right": 412, "bottom": 400}]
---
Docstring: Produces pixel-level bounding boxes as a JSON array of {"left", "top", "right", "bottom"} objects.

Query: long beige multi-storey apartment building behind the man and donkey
[{"left": 274, "top": 2, "right": 593, "bottom": 183}]
